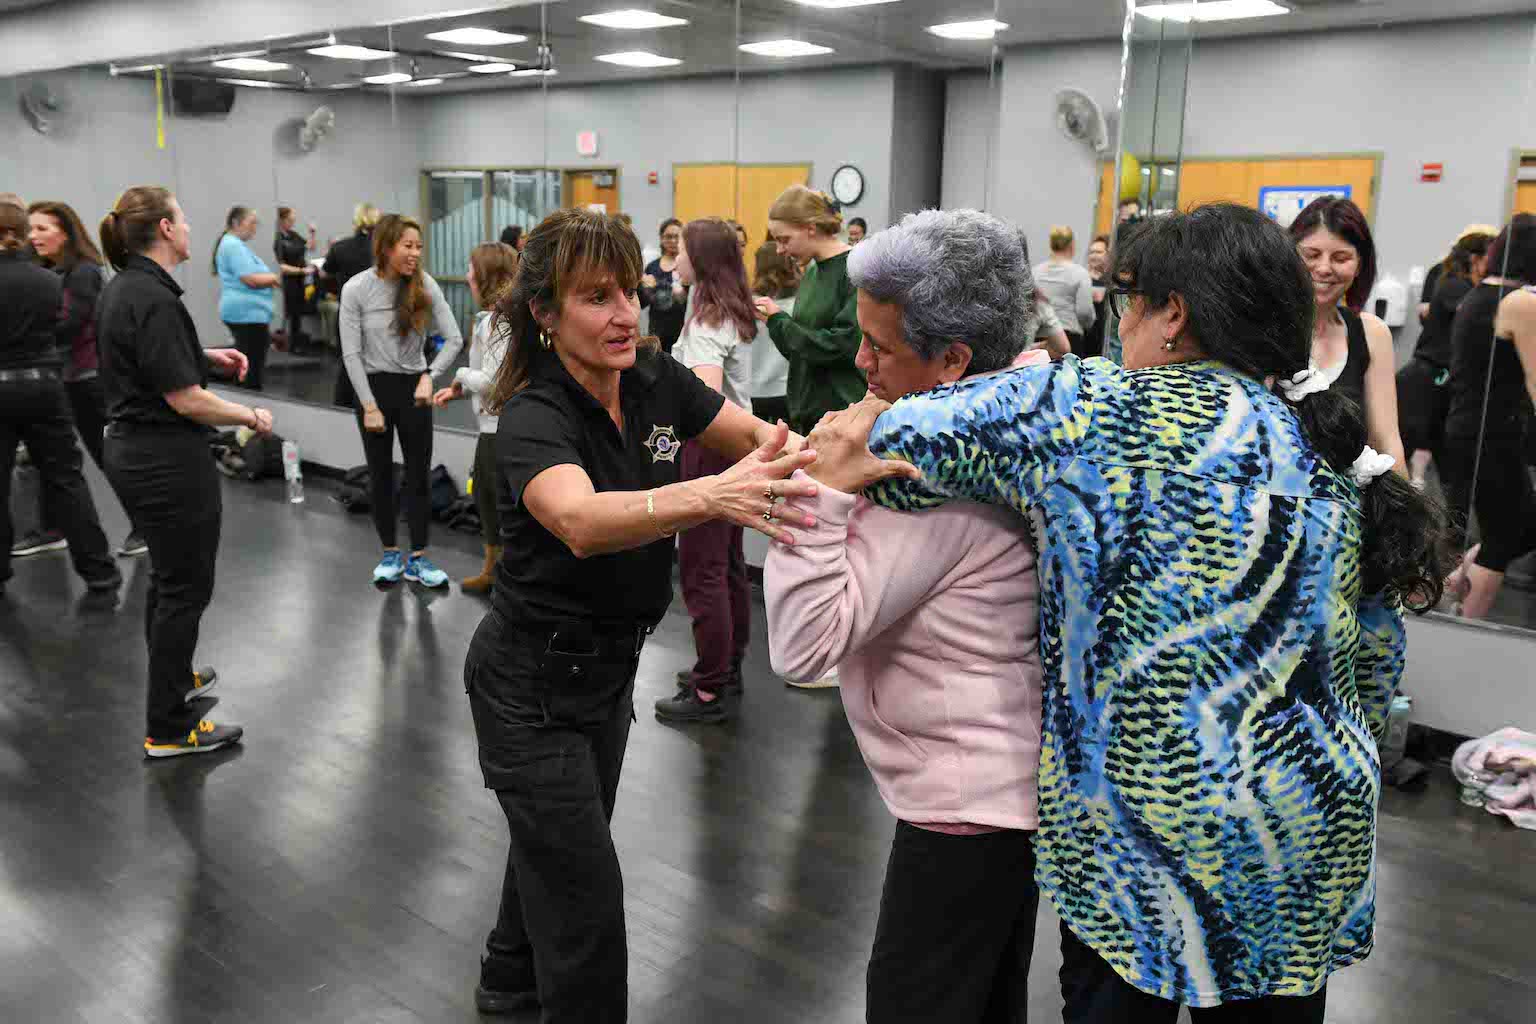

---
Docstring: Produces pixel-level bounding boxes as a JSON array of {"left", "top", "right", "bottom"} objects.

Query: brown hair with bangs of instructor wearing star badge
[{"left": 485, "top": 210, "right": 660, "bottom": 415}]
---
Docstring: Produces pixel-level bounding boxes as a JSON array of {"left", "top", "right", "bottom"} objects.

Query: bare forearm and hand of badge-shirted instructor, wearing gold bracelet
[{"left": 522, "top": 420, "right": 816, "bottom": 559}]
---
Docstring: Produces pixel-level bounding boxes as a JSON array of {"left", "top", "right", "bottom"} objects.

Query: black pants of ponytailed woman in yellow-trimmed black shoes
[{"left": 106, "top": 425, "right": 223, "bottom": 740}]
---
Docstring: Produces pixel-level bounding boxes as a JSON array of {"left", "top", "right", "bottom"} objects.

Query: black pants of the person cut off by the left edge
[{"left": 0, "top": 376, "right": 118, "bottom": 583}]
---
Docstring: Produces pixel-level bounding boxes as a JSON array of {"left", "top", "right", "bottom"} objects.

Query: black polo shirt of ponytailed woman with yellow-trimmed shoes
[{"left": 97, "top": 256, "right": 207, "bottom": 430}]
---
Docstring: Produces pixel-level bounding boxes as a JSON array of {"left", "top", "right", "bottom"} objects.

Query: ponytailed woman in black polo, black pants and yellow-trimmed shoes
[{"left": 97, "top": 186, "right": 272, "bottom": 757}]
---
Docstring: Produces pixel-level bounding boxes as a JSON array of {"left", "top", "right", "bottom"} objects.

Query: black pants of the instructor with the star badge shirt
[{"left": 464, "top": 613, "right": 639, "bottom": 1024}]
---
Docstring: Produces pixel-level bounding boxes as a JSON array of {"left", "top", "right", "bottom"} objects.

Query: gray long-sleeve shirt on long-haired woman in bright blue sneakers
[{"left": 341, "top": 267, "right": 464, "bottom": 405}]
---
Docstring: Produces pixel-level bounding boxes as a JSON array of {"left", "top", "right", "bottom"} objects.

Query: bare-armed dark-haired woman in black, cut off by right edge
[{"left": 1435, "top": 213, "right": 1536, "bottom": 619}]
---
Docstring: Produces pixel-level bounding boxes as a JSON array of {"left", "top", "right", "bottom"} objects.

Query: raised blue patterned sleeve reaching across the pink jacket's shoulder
[{"left": 865, "top": 356, "right": 1094, "bottom": 511}]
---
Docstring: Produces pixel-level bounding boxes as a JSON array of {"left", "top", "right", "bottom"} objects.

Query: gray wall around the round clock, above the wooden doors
[{"left": 415, "top": 68, "right": 895, "bottom": 241}]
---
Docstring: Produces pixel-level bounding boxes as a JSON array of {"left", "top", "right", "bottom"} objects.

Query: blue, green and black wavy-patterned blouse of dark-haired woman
[{"left": 868, "top": 358, "right": 1404, "bottom": 1007}]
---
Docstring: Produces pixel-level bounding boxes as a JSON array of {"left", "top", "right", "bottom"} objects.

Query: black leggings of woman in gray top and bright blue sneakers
[{"left": 356, "top": 373, "right": 432, "bottom": 551}]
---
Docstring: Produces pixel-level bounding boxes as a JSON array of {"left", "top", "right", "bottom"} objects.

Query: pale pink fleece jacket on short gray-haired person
[{"left": 763, "top": 356, "right": 1040, "bottom": 831}]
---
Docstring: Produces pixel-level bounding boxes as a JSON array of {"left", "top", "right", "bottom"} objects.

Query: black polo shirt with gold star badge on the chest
[{"left": 493, "top": 350, "right": 725, "bottom": 628}]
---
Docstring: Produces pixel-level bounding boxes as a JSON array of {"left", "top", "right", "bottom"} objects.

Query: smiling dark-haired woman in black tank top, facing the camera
[{"left": 1290, "top": 197, "right": 1407, "bottom": 471}]
